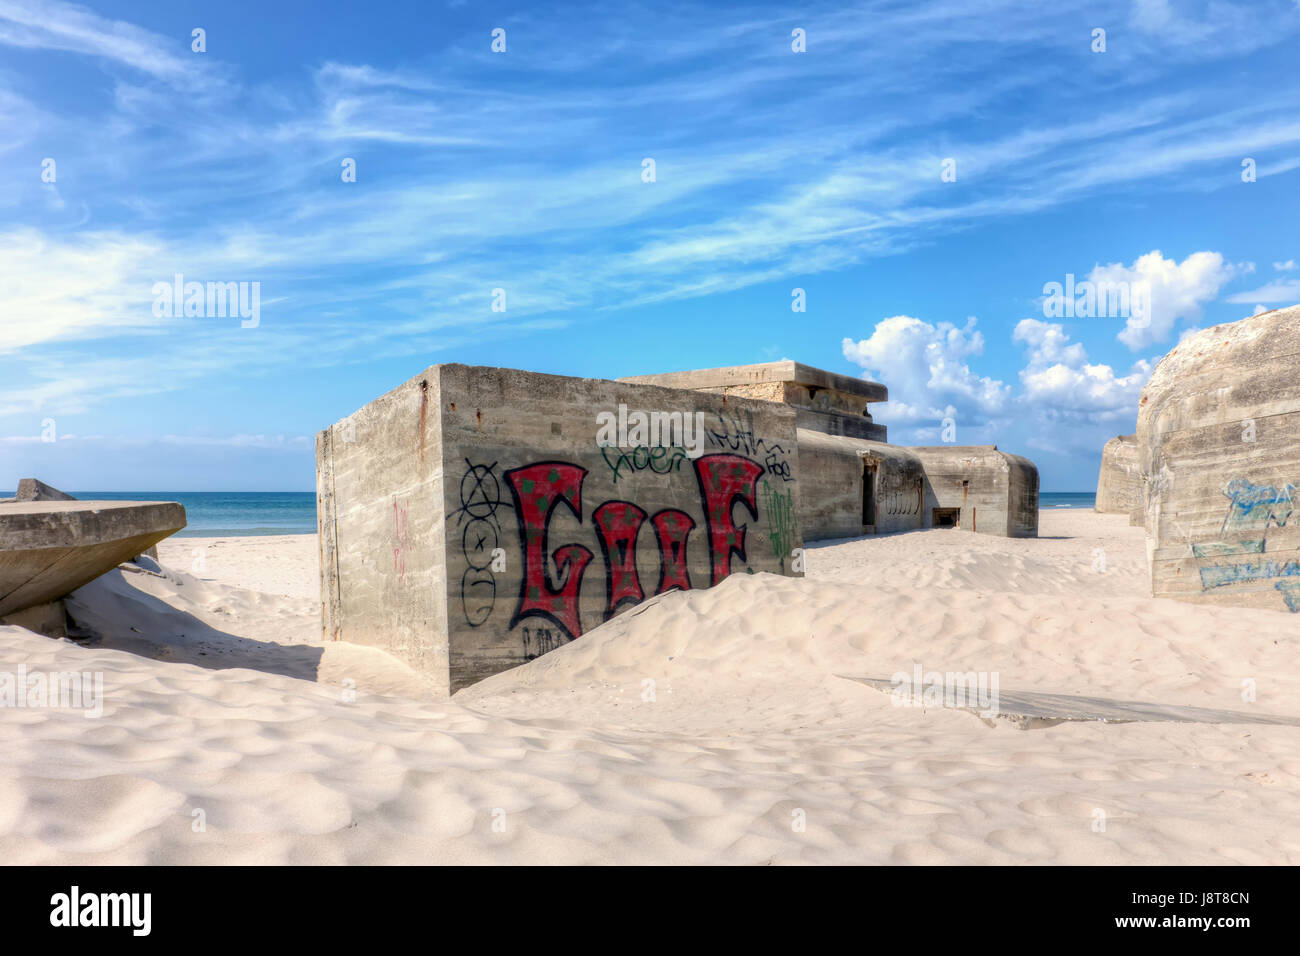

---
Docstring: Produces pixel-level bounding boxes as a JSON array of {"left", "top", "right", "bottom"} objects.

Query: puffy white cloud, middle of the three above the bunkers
[{"left": 1011, "top": 319, "right": 1151, "bottom": 421}]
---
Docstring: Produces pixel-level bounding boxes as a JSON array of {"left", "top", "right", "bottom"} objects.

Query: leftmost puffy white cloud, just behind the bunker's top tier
[{"left": 842, "top": 315, "right": 1011, "bottom": 424}]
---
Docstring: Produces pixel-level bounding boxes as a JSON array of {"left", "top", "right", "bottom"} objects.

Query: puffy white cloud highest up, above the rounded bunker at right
[{"left": 1088, "top": 250, "right": 1255, "bottom": 351}]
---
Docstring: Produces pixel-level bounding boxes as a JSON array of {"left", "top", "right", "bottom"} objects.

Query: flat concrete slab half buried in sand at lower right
[{"left": 836, "top": 674, "right": 1300, "bottom": 730}]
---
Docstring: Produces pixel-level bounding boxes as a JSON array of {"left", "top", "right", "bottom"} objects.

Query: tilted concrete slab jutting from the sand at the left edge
[{"left": 0, "top": 489, "right": 185, "bottom": 637}]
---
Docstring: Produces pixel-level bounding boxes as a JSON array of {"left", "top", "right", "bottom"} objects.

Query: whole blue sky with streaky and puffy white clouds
[{"left": 0, "top": 0, "right": 1300, "bottom": 490}]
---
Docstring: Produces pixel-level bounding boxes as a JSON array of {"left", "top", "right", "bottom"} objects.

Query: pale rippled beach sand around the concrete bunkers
[{"left": 0, "top": 511, "right": 1300, "bottom": 864}]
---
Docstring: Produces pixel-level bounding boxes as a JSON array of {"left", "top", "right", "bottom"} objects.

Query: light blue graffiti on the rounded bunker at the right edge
[{"left": 1192, "top": 479, "right": 1300, "bottom": 613}]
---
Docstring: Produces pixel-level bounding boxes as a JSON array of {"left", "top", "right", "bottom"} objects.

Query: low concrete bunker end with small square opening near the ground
[{"left": 907, "top": 445, "right": 1039, "bottom": 537}]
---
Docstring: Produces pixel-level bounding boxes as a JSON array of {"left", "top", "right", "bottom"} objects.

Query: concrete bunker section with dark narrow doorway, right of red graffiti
[{"left": 798, "top": 428, "right": 924, "bottom": 540}]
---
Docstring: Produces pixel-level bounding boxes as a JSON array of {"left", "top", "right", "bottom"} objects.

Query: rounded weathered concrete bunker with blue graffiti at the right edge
[{"left": 1138, "top": 306, "right": 1300, "bottom": 611}]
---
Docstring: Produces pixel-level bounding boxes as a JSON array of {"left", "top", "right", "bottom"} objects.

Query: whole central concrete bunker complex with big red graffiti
[{"left": 316, "top": 362, "right": 1037, "bottom": 693}]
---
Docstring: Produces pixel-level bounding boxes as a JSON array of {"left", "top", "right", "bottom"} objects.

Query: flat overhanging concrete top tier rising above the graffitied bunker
[{"left": 619, "top": 360, "right": 889, "bottom": 441}]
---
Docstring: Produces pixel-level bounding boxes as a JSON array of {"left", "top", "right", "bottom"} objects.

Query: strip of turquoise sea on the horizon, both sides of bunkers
[{"left": 0, "top": 492, "right": 1097, "bottom": 537}]
